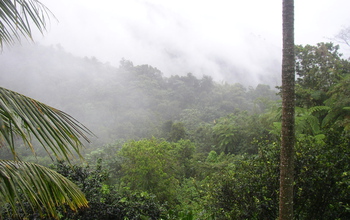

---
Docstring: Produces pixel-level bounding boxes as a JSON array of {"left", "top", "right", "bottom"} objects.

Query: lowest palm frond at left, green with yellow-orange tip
[{"left": 0, "top": 160, "right": 88, "bottom": 217}]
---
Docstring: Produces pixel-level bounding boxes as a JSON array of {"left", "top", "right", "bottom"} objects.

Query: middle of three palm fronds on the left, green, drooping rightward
[{"left": 0, "top": 87, "right": 93, "bottom": 160}]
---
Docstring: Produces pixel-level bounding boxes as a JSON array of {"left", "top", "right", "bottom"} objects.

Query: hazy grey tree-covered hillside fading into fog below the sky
[{"left": 0, "top": 44, "right": 277, "bottom": 147}]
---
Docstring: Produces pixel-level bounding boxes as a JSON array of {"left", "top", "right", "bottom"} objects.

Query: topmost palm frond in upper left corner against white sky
[{"left": 0, "top": 0, "right": 53, "bottom": 48}]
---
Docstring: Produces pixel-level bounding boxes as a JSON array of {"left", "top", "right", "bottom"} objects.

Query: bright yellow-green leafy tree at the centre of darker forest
[{"left": 119, "top": 138, "right": 181, "bottom": 203}]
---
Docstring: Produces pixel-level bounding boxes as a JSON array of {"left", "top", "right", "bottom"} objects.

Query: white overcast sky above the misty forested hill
[{"left": 29, "top": 0, "right": 350, "bottom": 84}]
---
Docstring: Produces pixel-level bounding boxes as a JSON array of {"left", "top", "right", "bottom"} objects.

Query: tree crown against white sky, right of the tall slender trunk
[{"left": 295, "top": 43, "right": 349, "bottom": 108}]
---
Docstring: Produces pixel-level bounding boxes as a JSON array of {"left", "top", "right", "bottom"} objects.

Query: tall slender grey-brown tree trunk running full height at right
[{"left": 279, "top": 0, "right": 295, "bottom": 220}]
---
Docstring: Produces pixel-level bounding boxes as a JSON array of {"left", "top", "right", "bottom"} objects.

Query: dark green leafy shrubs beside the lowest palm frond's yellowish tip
[{"left": 51, "top": 161, "right": 166, "bottom": 220}]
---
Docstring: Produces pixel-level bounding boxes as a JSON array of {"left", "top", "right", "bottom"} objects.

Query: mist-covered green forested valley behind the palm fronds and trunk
[{"left": 0, "top": 43, "right": 350, "bottom": 220}]
